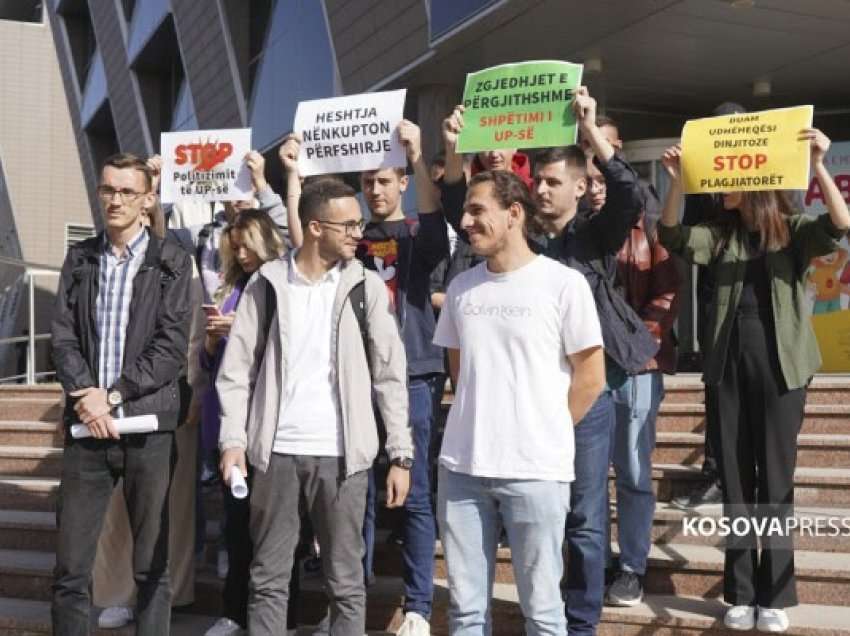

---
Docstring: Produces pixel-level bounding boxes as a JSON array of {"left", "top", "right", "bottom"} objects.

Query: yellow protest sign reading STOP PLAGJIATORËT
[{"left": 682, "top": 106, "right": 814, "bottom": 194}]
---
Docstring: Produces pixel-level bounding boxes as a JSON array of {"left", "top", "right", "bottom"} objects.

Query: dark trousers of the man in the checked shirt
[{"left": 51, "top": 431, "right": 177, "bottom": 636}]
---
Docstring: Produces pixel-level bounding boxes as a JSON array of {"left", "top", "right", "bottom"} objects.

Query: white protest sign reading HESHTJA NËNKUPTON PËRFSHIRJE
[{"left": 294, "top": 89, "right": 407, "bottom": 177}]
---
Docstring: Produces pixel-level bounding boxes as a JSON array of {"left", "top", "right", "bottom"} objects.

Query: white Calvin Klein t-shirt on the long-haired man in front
[{"left": 434, "top": 256, "right": 602, "bottom": 481}]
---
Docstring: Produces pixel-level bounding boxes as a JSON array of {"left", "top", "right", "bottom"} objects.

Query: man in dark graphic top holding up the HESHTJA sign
[{"left": 357, "top": 120, "right": 449, "bottom": 636}]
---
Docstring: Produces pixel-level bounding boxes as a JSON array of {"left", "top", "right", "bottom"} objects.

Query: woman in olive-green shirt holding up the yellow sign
[{"left": 658, "top": 128, "right": 850, "bottom": 632}]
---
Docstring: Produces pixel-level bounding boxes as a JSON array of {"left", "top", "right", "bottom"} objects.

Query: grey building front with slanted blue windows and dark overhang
[{"left": 46, "top": 0, "right": 850, "bottom": 362}]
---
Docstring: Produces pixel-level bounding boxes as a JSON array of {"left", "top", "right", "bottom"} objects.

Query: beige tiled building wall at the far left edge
[{"left": 0, "top": 0, "right": 92, "bottom": 378}]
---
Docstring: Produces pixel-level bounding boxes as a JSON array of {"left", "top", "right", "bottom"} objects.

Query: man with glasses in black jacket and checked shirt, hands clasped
[{"left": 51, "top": 154, "right": 192, "bottom": 636}]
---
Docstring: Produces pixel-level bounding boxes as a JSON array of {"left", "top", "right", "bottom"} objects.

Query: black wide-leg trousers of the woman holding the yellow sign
[{"left": 712, "top": 315, "right": 806, "bottom": 608}]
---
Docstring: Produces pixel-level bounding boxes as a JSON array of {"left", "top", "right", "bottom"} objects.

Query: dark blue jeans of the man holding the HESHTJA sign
[{"left": 363, "top": 375, "right": 444, "bottom": 618}]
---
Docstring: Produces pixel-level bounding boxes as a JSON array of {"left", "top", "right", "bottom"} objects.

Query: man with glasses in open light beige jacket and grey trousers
[{"left": 216, "top": 179, "right": 413, "bottom": 636}]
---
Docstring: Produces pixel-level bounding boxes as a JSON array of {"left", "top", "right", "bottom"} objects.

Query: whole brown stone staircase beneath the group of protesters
[{"left": 0, "top": 376, "right": 850, "bottom": 636}]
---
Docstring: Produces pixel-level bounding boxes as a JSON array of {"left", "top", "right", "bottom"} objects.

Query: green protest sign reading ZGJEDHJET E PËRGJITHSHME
[{"left": 457, "top": 61, "right": 583, "bottom": 152}]
